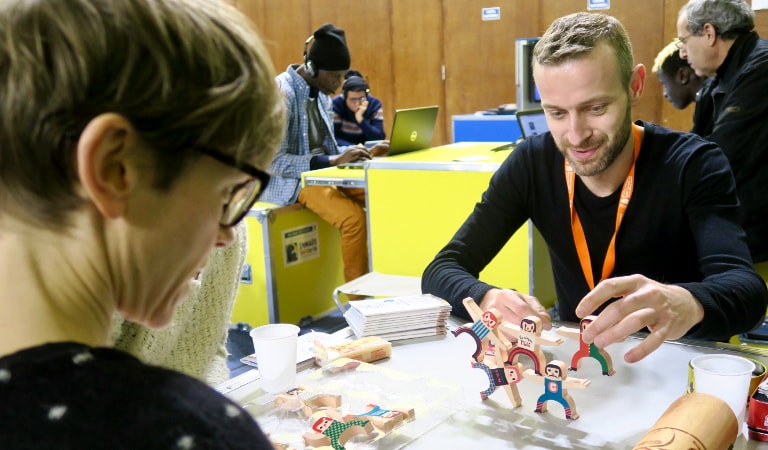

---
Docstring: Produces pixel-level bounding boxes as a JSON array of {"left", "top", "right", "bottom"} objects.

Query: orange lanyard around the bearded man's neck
[{"left": 565, "top": 124, "right": 641, "bottom": 290}]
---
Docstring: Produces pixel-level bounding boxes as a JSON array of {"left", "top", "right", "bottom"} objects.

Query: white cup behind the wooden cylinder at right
[{"left": 691, "top": 354, "right": 755, "bottom": 430}]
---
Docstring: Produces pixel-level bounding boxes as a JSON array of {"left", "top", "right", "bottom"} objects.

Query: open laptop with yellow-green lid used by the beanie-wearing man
[{"left": 338, "top": 105, "right": 438, "bottom": 168}]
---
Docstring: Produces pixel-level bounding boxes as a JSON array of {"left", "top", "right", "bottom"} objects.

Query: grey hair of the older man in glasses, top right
[{"left": 678, "top": 0, "right": 755, "bottom": 40}]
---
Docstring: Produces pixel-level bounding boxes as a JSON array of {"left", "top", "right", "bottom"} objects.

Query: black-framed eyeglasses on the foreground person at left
[{"left": 193, "top": 147, "right": 269, "bottom": 227}]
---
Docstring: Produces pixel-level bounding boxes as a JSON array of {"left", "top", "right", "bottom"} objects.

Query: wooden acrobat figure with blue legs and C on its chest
[{"left": 523, "top": 360, "right": 591, "bottom": 420}]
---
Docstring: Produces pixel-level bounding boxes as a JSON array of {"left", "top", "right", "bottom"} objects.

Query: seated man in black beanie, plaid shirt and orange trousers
[{"left": 263, "top": 23, "right": 389, "bottom": 281}]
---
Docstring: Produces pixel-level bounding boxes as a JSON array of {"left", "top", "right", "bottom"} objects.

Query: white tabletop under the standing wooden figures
[{"left": 220, "top": 318, "right": 768, "bottom": 450}]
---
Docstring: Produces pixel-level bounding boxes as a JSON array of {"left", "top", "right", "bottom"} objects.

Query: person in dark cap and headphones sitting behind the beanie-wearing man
[{"left": 333, "top": 70, "right": 386, "bottom": 145}]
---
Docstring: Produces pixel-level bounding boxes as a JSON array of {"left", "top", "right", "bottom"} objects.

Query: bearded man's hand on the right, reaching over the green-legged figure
[{"left": 576, "top": 275, "right": 704, "bottom": 363}]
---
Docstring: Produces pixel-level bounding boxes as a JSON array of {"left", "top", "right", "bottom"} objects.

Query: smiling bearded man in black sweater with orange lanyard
[{"left": 422, "top": 13, "right": 768, "bottom": 363}]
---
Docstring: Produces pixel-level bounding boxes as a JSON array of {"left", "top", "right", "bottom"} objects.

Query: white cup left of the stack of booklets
[{"left": 250, "top": 323, "right": 299, "bottom": 393}]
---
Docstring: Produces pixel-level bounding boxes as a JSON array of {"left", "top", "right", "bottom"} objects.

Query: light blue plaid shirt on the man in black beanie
[{"left": 261, "top": 65, "right": 340, "bottom": 205}]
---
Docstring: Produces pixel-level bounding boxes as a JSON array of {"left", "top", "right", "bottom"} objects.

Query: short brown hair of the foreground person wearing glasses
[{"left": 0, "top": 0, "right": 283, "bottom": 227}]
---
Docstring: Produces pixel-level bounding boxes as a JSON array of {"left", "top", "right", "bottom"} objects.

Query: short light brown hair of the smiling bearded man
[{"left": 533, "top": 12, "right": 634, "bottom": 86}]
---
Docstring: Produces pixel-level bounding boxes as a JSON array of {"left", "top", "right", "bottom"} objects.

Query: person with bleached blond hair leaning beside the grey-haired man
[{"left": 651, "top": 41, "right": 706, "bottom": 113}]
